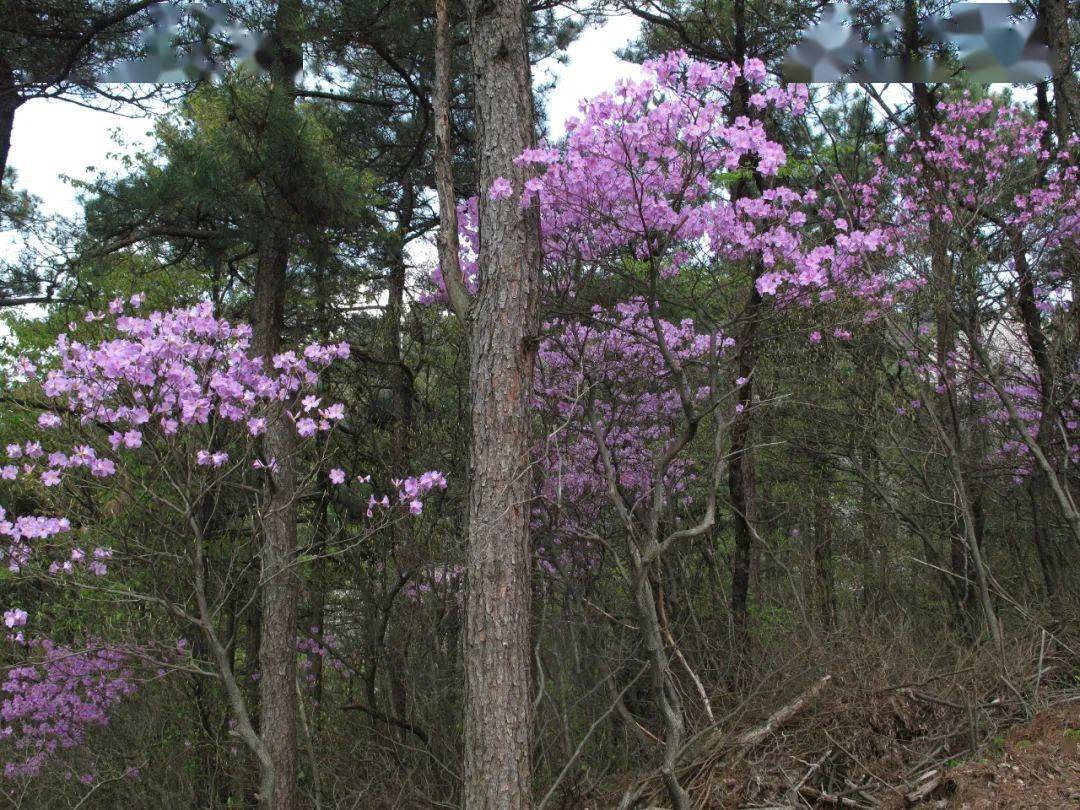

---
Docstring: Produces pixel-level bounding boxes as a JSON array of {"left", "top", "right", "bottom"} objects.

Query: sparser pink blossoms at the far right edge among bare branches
[{"left": 896, "top": 96, "right": 1080, "bottom": 482}]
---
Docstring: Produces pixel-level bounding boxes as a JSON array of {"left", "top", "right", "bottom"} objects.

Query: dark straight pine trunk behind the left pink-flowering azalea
[{"left": 254, "top": 0, "right": 302, "bottom": 810}]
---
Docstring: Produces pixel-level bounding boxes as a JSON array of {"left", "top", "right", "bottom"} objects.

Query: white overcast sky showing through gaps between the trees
[{"left": 9, "top": 15, "right": 638, "bottom": 226}]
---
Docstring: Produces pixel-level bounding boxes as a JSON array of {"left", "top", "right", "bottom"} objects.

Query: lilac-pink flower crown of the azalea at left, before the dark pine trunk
[{"left": 0, "top": 296, "right": 349, "bottom": 626}]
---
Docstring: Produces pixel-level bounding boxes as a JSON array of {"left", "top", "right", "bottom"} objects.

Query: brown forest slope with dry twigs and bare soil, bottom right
[{"left": 609, "top": 666, "right": 1080, "bottom": 810}]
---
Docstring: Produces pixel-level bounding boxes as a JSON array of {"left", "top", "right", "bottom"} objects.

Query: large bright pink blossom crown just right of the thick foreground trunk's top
[{"left": 426, "top": 52, "right": 898, "bottom": 330}]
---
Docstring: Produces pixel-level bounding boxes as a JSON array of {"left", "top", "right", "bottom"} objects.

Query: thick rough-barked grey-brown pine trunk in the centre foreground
[{"left": 464, "top": 0, "right": 540, "bottom": 810}]
